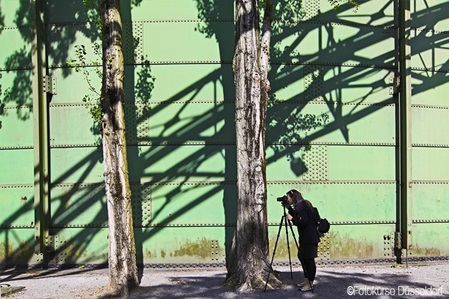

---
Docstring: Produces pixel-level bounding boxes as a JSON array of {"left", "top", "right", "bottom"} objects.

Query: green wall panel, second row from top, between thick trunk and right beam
[{"left": 276, "top": 23, "right": 395, "bottom": 68}]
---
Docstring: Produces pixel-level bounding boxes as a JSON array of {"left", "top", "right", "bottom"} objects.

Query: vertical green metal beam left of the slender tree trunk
[{"left": 30, "top": 0, "right": 49, "bottom": 266}]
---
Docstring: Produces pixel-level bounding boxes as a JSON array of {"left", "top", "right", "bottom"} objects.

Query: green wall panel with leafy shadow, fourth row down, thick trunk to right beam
[{"left": 267, "top": 101, "right": 396, "bottom": 145}]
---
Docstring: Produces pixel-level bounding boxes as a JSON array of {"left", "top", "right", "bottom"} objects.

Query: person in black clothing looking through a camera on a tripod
[{"left": 282, "top": 189, "right": 320, "bottom": 292}]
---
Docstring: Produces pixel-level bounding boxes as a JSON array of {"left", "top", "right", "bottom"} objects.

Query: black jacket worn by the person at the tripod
[{"left": 288, "top": 200, "right": 320, "bottom": 244}]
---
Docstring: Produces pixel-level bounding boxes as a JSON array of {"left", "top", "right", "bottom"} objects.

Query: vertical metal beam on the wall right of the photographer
[{"left": 397, "top": 0, "right": 412, "bottom": 262}]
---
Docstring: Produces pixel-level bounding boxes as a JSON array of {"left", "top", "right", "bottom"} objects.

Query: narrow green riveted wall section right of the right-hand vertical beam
[{"left": 407, "top": 0, "right": 449, "bottom": 258}]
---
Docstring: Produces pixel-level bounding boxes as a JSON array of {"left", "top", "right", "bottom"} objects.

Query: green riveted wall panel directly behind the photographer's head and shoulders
[{"left": 268, "top": 181, "right": 396, "bottom": 225}]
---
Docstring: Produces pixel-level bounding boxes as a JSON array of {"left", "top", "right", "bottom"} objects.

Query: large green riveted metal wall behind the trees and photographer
[{"left": 0, "top": 0, "right": 449, "bottom": 264}]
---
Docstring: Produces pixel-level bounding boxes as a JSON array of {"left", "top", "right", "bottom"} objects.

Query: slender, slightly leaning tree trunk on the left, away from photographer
[{"left": 100, "top": 0, "right": 138, "bottom": 297}]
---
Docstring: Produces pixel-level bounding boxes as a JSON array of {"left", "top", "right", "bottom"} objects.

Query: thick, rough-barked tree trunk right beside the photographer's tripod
[{"left": 228, "top": 0, "right": 280, "bottom": 291}]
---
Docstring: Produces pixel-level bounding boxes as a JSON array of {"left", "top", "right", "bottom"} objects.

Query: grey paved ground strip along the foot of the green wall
[{"left": 0, "top": 261, "right": 449, "bottom": 299}]
